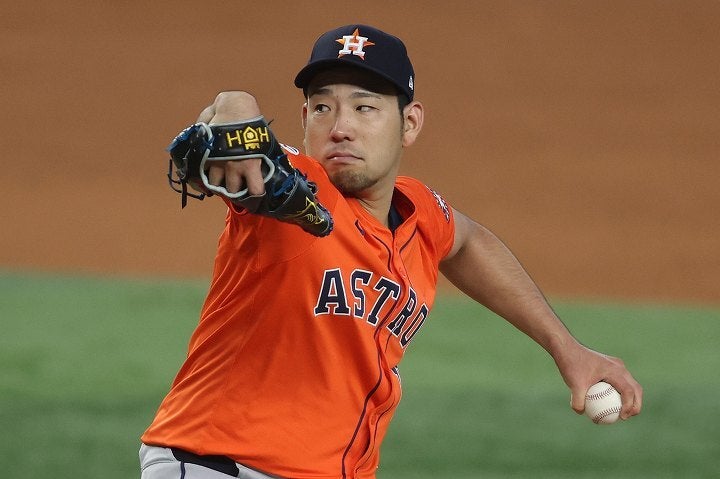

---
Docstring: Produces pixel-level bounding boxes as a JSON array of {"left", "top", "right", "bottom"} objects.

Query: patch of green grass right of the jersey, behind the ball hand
[{"left": 386, "top": 299, "right": 720, "bottom": 479}]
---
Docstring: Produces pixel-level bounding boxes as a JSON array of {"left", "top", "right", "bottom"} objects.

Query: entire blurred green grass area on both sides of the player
[{"left": 0, "top": 273, "right": 720, "bottom": 479}]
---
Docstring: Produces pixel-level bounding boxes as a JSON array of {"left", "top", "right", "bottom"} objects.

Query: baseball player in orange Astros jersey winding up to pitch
[{"left": 140, "top": 25, "right": 642, "bottom": 479}]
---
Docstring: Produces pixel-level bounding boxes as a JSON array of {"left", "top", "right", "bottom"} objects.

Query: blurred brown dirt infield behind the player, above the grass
[{"left": 0, "top": 0, "right": 720, "bottom": 303}]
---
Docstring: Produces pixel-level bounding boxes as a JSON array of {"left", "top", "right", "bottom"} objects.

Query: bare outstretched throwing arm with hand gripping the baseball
[{"left": 440, "top": 210, "right": 642, "bottom": 419}]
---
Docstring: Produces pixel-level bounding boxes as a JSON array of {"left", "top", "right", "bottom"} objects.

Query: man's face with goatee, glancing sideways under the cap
[{"left": 303, "top": 72, "right": 404, "bottom": 197}]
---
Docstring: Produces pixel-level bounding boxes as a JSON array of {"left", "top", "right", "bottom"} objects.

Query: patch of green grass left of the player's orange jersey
[{"left": 0, "top": 275, "right": 205, "bottom": 479}]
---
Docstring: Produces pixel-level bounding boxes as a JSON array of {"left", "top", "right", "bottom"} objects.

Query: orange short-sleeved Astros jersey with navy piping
[{"left": 142, "top": 149, "right": 454, "bottom": 479}]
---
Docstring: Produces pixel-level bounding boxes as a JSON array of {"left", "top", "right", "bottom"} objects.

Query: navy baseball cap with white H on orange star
[{"left": 295, "top": 25, "right": 415, "bottom": 101}]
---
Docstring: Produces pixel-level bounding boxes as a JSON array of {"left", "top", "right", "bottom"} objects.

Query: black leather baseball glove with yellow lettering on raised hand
[{"left": 167, "top": 116, "right": 333, "bottom": 236}]
